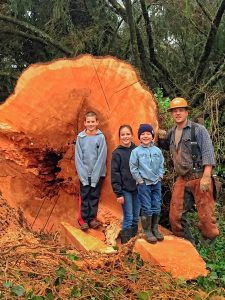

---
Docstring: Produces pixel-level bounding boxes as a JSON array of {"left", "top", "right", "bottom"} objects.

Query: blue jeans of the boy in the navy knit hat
[{"left": 138, "top": 181, "right": 162, "bottom": 216}]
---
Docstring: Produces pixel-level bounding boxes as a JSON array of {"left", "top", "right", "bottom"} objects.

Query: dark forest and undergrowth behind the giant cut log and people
[{"left": 0, "top": 0, "right": 225, "bottom": 296}]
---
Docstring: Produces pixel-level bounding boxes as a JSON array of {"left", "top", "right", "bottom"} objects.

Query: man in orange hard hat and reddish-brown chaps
[{"left": 159, "top": 98, "right": 219, "bottom": 242}]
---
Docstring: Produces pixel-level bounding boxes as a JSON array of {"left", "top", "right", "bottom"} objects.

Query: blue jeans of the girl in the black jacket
[{"left": 122, "top": 191, "right": 140, "bottom": 230}]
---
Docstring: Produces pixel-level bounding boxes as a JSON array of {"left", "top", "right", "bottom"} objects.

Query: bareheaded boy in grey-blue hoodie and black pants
[{"left": 75, "top": 111, "right": 107, "bottom": 231}]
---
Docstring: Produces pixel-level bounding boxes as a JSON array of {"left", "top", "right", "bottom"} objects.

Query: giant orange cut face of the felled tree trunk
[{"left": 0, "top": 55, "right": 158, "bottom": 236}]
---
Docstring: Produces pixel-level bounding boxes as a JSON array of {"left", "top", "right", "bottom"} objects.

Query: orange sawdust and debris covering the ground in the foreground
[{"left": 0, "top": 197, "right": 211, "bottom": 300}]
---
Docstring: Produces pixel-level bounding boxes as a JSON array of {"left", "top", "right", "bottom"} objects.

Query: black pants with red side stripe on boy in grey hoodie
[{"left": 78, "top": 178, "right": 102, "bottom": 225}]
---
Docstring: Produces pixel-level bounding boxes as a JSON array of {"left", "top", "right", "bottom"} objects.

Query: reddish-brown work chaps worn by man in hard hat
[{"left": 169, "top": 177, "right": 219, "bottom": 240}]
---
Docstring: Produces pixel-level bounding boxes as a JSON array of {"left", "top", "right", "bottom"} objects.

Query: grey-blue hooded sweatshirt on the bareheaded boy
[{"left": 75, "top": 129, "right": 107, "bottom": 187}]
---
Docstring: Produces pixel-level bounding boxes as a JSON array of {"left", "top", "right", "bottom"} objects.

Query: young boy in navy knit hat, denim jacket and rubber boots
[{"left": 130, "top": 124, "right": 164, "bottom": 244}]
